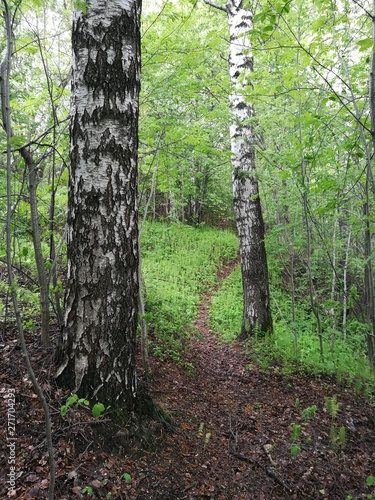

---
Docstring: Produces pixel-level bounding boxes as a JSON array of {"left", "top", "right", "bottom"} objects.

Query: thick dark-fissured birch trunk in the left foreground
[{"left": 57, "top": 0, "right": 141, "bottom": 414}]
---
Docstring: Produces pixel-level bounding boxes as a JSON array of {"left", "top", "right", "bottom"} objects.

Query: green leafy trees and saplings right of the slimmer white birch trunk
[{"left": 248, "top": 1, "right": 373, "bottom": 372}]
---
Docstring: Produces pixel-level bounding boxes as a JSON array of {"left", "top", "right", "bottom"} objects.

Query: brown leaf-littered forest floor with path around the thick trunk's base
[{"left": 0, "top": 260, "right": 375, "bottom": 500}]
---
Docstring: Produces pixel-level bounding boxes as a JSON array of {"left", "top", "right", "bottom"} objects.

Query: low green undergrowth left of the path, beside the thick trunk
[{"left": 141, "top": 222, "right": 238, "bottom": 361}]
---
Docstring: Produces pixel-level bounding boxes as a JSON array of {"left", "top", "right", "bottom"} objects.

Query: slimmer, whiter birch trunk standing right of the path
[{"left": 226, "top": 0, "right": 272, "bottom": 337}]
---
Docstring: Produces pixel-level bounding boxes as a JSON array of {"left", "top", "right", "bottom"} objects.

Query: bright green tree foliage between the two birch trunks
[{"left": 140, "top": 2, "right": 233, "bottom": 225}]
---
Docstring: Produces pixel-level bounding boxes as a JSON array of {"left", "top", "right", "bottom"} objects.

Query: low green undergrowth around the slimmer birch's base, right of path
[{"left": 210, "top": 266, "right": 374, "bottom": 388}]
